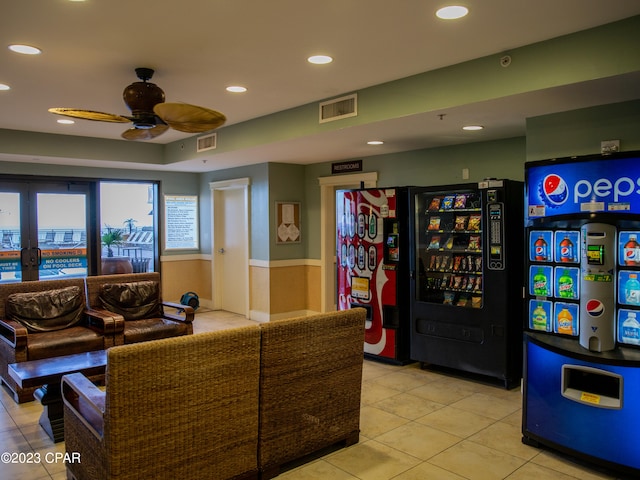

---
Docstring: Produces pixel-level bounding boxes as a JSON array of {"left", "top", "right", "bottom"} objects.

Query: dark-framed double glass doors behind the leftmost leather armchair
[{"left": 0, "top": 180, "right": 96, "bottom": 283}]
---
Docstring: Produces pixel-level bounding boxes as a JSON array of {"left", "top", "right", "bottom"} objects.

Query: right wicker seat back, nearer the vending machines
[{"left": 258, "top": 308, "right": 366, "bottom": 479}]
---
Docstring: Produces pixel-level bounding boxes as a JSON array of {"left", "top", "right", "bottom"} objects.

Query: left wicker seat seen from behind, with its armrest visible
[{"left": 62, "top": 326, "right": 260, "bottom": 480}]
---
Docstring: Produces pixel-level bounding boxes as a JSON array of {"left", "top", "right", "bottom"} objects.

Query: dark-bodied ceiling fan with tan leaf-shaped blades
[{"left": 49, "top": 68, "right": 227, "bottom": 140}]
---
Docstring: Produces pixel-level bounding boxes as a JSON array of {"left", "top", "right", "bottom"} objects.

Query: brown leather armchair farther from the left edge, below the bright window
[{"left": 86, "top": 272, "right": 194, "bottom": 345}]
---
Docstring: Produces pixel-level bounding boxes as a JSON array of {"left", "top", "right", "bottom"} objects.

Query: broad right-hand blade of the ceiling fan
[{"left": 153, "top": 103, "right": 227, "bottom": 133}]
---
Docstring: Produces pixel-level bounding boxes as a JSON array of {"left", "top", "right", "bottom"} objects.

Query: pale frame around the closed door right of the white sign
[{"left": 209, "top": 177, "right": 251, "bottom": 317}]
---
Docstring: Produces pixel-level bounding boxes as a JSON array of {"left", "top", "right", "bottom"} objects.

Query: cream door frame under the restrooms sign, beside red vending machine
[{"left": 318, "top": 172, "right": 378, "bottom": 312}]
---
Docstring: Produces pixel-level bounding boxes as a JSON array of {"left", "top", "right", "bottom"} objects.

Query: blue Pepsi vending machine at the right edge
[{"left": 522, "top": 152, "right": 640, "bottom": 476}]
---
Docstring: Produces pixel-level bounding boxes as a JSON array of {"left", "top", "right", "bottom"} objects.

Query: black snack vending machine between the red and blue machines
[{"left": 409, "top": 180, "right": 524, "bottom": 388}]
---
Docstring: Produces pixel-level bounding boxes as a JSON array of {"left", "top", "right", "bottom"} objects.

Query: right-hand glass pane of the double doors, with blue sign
[{"left": 36, "top": 192, "right": 87, "bottom": 279}]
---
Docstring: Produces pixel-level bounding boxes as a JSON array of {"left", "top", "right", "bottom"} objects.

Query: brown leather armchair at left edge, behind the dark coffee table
[{"left": 0, "top": 278, "right": 124, "bottom": 403}]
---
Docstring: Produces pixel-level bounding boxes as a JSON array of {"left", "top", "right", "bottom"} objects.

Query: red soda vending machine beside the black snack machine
[{"left": 336, "top": 187, "right": 409, "bottom": 364}]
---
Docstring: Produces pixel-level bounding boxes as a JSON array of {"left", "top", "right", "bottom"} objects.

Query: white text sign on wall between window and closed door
[{"left": 164, "top": 195, "right": 199, "bottom": 250}]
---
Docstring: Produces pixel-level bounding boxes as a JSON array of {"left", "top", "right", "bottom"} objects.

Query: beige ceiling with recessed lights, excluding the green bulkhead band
[{"left": 0, "top": 0, "right": 640, "bottom": 171}]
